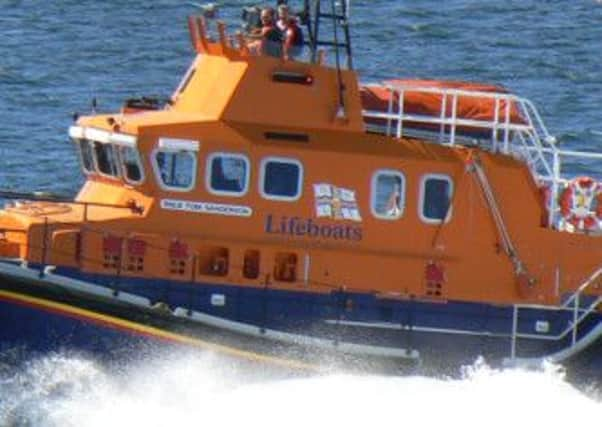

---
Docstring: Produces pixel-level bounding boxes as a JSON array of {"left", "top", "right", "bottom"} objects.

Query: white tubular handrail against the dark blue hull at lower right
[{"left": 510, "top": 267, "right": 602, "bottom": 359}]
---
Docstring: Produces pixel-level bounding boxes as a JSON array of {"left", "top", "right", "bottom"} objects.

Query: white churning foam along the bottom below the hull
[{"left": 0, "top": 355, "right": 602, "bottom": 427}]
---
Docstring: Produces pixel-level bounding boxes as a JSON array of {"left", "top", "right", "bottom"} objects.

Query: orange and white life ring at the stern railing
[{"left": 558, "top": 176, "right": 602, "bottom": 232}]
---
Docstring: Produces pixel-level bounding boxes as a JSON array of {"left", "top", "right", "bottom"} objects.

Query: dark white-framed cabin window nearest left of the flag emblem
[{"left": 259, "top": 157, "right": 303, "bottom": 200}]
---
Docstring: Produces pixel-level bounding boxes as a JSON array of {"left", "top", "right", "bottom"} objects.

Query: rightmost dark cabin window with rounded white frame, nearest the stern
[{"left": 419, "top": 175, "right": 453, "bottom": 224}]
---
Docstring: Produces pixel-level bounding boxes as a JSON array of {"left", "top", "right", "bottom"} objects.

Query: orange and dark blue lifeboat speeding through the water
[{"left": 0, "top": 1, "right": 602, "bottom": 372}]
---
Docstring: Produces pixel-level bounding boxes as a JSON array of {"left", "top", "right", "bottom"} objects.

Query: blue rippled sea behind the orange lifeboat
[{"left": 0, "top": 0, "right": 602, "bottom": 193}]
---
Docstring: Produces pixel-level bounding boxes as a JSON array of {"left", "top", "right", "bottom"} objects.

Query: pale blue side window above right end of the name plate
[{"left": 207, "top": 153, "right": 250, "bottom": 196}]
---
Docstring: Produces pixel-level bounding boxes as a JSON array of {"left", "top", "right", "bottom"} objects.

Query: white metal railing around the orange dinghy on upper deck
[{"left": 363, "top": 84, "right": 602, "bottom": 232}]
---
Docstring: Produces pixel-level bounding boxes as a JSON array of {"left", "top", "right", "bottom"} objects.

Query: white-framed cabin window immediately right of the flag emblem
[{"left": 371, "top": 170, "right": 405, "bottom": 219}]
